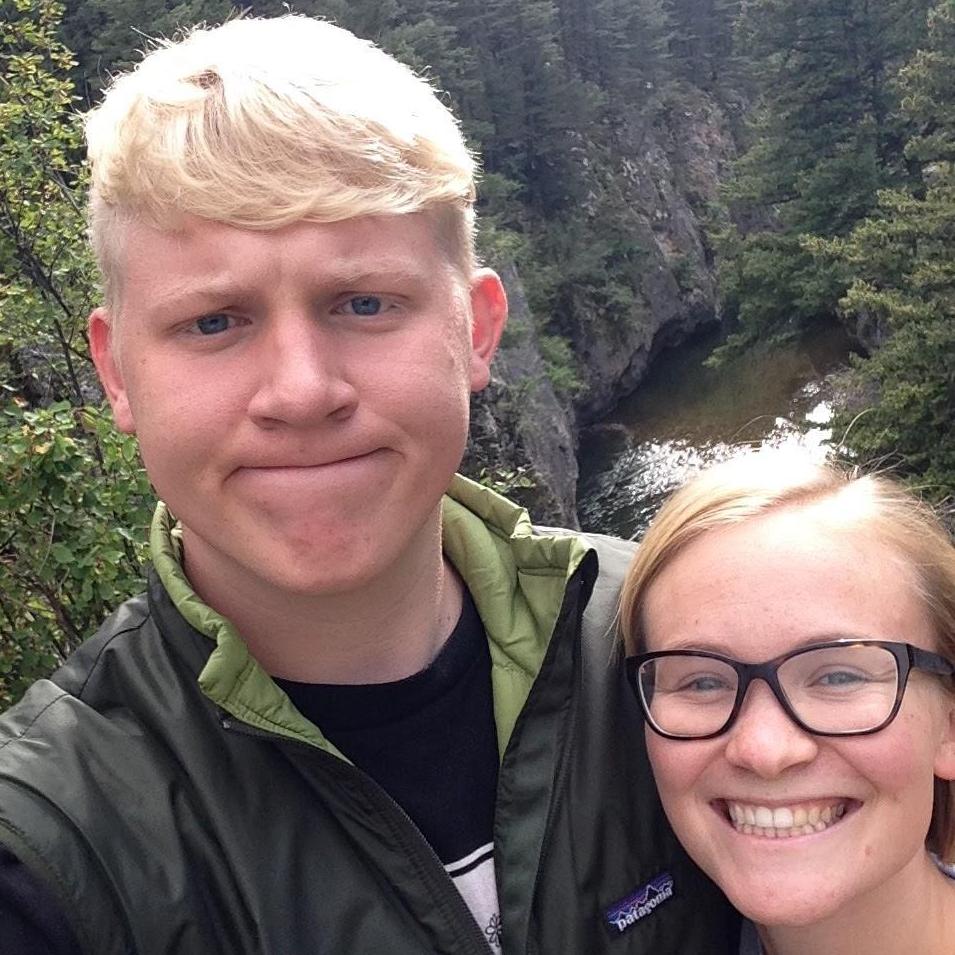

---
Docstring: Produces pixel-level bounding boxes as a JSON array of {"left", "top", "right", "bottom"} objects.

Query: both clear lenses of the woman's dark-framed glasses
[{"left": 639, "top": 644, "right": 898, "bottom": 737}]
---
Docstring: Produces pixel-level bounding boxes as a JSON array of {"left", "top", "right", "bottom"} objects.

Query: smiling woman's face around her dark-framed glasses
[{"left": 642, "top": 504, "right": 955, "bottom": 925}]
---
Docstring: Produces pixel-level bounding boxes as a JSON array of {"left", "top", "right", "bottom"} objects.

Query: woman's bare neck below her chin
[{"left": 757, "top": 852, "right": 955, "bottom": 955}]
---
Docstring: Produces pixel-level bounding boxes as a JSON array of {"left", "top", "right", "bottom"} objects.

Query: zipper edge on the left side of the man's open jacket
[{"left": 220, "top": 714, "right": 491, "bottom": 955}]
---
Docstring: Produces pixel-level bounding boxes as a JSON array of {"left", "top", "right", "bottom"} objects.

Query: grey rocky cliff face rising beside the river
[{"left": 464, "top": 93, "right": 735, "bottom": 526}]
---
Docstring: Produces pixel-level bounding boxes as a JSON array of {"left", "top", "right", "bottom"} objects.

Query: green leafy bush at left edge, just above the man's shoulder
[{"left": 0, "top": 402, "right": 152, "bottom": 709}]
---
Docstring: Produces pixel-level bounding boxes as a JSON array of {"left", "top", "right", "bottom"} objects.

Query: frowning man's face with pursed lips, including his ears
[{"left": 90, "top": 214, "right": 506, "bottom": 595}]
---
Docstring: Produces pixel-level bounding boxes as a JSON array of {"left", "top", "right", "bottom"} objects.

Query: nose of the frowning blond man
[{"left": 249, "top": 314, "right": 358, "bottom": 427}]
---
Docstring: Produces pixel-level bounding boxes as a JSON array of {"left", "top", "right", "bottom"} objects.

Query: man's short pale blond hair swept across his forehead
[{"left": 86, "top": 15, "right": 475, "bottom": 302}]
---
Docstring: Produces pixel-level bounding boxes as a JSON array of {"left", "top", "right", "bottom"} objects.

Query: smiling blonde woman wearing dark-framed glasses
[{"left": 621, "top": 453, "right": 955, "bottom": 955}]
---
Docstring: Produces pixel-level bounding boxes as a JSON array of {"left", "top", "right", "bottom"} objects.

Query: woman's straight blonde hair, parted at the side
[{"left": 620, "top": 451, "right": 955, "bottom": 859}]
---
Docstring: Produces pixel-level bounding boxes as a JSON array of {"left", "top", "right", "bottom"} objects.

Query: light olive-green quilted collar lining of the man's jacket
[{"left": 150, "top": 476, "right": 589, "bottom": 759}]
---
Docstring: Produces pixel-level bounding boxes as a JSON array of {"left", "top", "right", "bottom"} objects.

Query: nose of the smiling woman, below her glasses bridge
[{"left": 725, "top": 680, "right": 819, "bottom": 779}]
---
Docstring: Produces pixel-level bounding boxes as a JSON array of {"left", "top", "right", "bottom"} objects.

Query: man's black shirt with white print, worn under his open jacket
[{"left": 0, "top": 591, "right": 499, "bottom": 955}]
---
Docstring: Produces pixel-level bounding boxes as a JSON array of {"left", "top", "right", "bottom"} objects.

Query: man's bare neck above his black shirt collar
[{"left": 184, "top": 526, "right": 464, "bottom": 683}]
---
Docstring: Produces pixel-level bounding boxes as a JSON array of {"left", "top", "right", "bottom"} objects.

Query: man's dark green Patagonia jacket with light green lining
[{"left": 0, "top": 479, "right": 739, "bottom": 955}]
